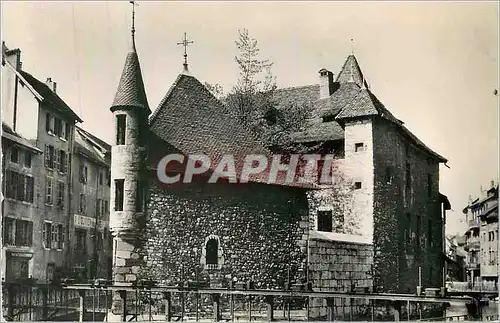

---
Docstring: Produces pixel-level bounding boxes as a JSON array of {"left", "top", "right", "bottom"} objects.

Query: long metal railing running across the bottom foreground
[{"left": 2, "top": 281, "right": 480, "bottom": 322}]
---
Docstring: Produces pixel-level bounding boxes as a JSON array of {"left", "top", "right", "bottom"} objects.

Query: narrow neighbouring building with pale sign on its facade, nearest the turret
[{"left": 69, "top": 127, "right": 112, "bottom": 278}]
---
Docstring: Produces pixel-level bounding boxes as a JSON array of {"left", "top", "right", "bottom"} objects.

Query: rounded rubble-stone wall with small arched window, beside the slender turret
[{"left": 140, "top": 183, "right": 308, "bottom": 288}]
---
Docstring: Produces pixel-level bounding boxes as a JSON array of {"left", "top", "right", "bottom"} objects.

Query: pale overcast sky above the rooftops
[{"left": 2, "top": 1, "right": 499, "bottom": 237}]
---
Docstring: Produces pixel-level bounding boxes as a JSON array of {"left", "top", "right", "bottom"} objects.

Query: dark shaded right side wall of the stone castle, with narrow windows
[{"left": 373, "top": 119, "right": 444, "bottom": 293}]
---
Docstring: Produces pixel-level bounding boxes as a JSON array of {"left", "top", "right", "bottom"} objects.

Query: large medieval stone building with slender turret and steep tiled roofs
[{"left": 110, "top": 19, "right": 450, "bottom": 317}]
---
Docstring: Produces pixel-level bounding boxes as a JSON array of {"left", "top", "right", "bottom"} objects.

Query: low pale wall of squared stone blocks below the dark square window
[{"left": 309, "top": 239, "right": 373, "bottom": 320}]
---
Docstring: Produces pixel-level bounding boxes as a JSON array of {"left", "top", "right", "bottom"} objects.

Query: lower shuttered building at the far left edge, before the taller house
[{"left": 1, "top": 124, "right": 44, "bottom": 281}]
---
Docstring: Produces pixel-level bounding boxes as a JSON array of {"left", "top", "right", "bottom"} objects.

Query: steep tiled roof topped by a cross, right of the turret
[{"left": 149, "top": 74, "right": 320, "bottom": 188}]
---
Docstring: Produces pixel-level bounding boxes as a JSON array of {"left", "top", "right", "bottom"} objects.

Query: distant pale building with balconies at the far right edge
[{"left": 463, "top": 182, "right": 499, "bottom": 284}]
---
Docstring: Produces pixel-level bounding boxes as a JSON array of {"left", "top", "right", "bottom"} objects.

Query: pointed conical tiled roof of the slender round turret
[{"left": 111, "top": 46, "right": 151, "bottom": 115}]
